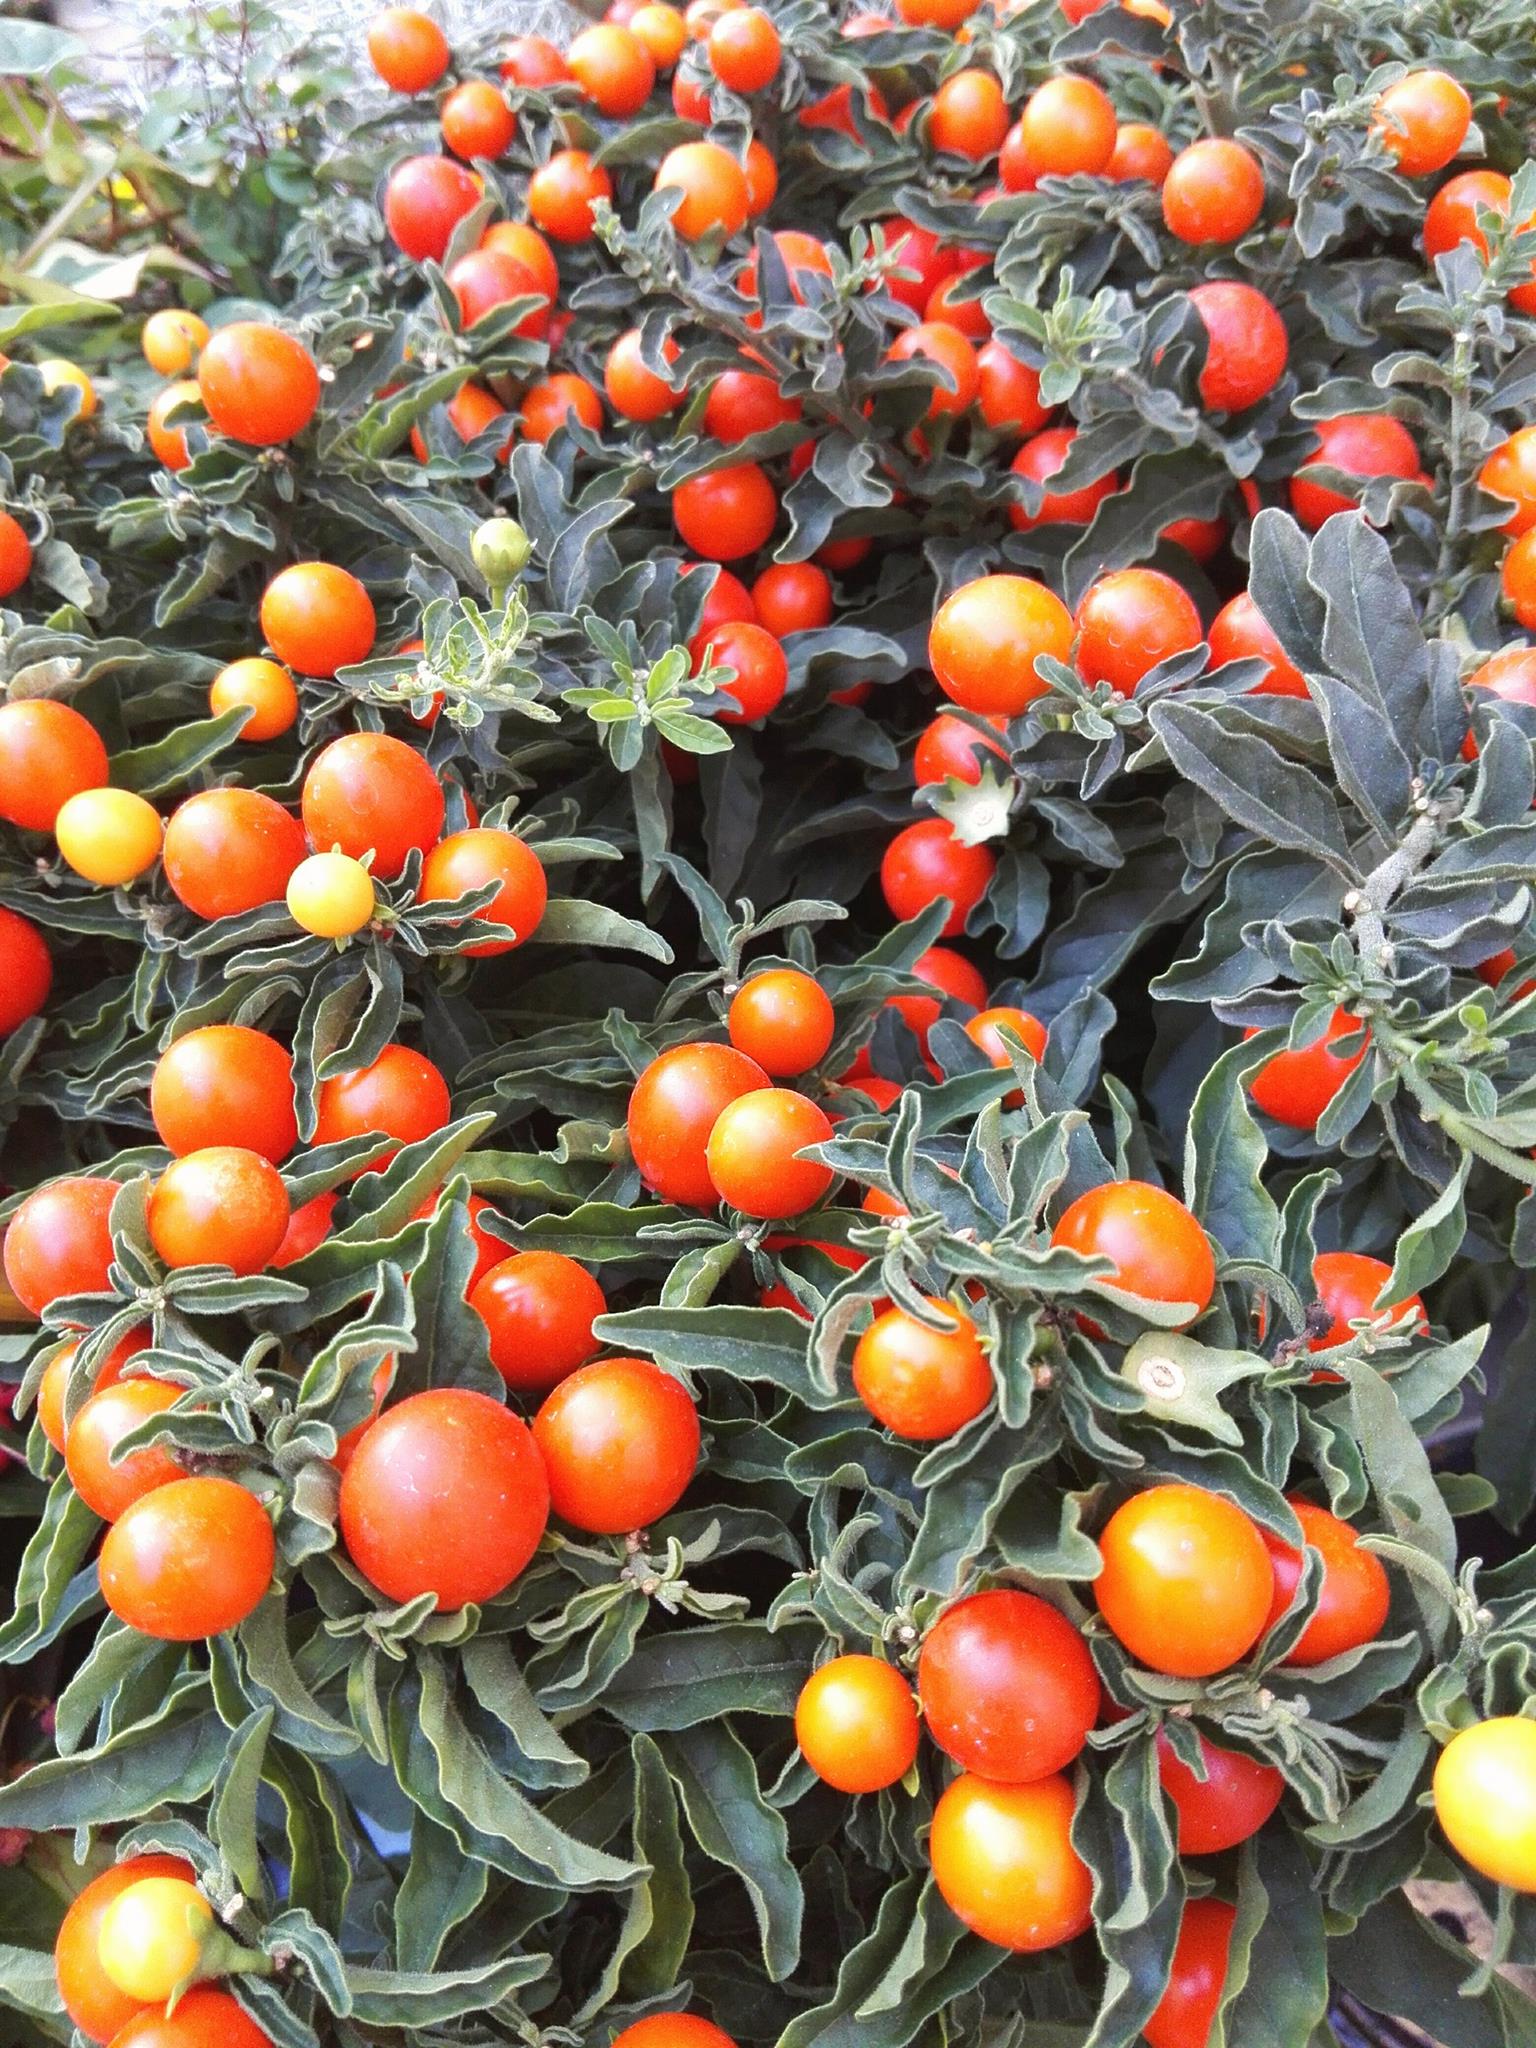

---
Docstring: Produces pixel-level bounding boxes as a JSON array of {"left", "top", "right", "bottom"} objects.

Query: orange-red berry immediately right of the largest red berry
[{"left": 532, "top": 1358, "right": 698, "bottom": 1536}]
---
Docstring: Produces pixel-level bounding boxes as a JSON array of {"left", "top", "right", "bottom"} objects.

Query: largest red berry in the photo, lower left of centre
[{"left": 340, "top": 1386, "right": 549, "bottom": 1614}]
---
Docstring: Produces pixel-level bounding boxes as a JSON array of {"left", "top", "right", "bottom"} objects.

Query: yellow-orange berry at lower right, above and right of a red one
[{"left": 1094, "top": 1485, "right": 1274, "bottom": 1677}]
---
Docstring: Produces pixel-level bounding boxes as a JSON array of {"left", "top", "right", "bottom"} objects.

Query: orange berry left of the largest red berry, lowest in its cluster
[{"left": 100, "top": 1477, "right": 276, "bottom": 1642}]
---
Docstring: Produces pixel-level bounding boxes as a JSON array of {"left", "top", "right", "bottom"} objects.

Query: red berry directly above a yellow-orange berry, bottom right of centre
[{"left": 918, "top": 1587, "right": 1100, "bottom": 1784}]
